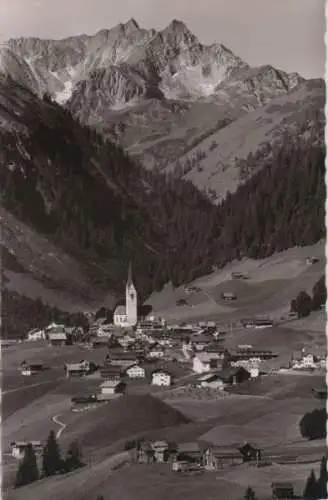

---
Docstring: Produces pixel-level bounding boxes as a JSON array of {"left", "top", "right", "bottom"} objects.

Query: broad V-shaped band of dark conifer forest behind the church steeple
[{"left": 0, "top": 89, "right": 325, "bottom": 308}]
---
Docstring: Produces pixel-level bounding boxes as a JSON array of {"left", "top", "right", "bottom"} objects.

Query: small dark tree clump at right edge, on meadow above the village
[{"left": 290, "top": 275, "right": 327, "bottom": 318}]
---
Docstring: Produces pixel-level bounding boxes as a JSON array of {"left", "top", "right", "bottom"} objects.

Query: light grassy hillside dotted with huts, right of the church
[{"left": 147, "top": 241, "right": 326, "bottom": 326}]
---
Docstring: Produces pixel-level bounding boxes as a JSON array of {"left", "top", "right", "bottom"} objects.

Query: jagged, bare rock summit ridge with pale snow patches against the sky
[{"left": 4, "top": 18, "right": 299, "bottom": 114}]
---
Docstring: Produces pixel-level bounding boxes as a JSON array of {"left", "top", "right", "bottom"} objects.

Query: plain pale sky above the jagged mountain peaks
[{"left": 0, "top": 0, "right": 325, "bottom": 78}]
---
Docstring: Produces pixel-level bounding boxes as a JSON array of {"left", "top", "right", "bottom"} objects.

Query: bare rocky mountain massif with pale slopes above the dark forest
[{"left": 0, "top": 19, "right": 325, "bottom": 200}]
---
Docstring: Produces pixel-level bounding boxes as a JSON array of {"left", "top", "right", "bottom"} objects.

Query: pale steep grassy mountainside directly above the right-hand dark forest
[{"left": 173, "top": 80, "right": 325, "bottom": 200}]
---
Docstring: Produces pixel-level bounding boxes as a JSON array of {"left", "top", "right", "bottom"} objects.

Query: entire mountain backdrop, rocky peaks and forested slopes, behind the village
[{"left": 0, "top": 19, "right": 325, "bottom": 334}]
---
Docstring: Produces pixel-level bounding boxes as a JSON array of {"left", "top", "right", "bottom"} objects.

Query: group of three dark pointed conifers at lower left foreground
[{"left": 15, "top": 431, "right": 84, "bottom": 488}]
